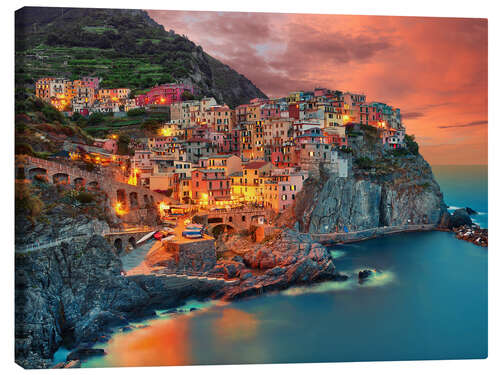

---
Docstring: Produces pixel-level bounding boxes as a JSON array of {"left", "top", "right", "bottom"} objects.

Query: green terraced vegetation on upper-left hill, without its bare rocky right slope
[{"left": 16, "top": 8, "right": 197, "bottom": 88}]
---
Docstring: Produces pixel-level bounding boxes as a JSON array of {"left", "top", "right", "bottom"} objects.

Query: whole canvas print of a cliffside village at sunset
[{"left": 15, "top": 7, "right": 488, "bottom": 369}]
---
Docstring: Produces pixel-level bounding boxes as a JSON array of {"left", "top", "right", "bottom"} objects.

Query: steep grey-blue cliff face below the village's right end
[{"left": 294, "top": 131, "right": 447, "bottom": 233}]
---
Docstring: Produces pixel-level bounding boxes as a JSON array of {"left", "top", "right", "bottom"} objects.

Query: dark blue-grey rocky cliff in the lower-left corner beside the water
[{"left": 15, "top": 236, "right": 147, "bottom": 368}]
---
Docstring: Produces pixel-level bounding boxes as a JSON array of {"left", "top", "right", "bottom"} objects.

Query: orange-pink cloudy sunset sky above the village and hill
[{"left": 148, "top": 10, "right": 488, "bottom": 165}]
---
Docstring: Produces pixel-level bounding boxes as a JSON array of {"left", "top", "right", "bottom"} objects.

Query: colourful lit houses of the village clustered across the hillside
[{"left": 31, "top": 77, "right": 405, "bottom": 213}]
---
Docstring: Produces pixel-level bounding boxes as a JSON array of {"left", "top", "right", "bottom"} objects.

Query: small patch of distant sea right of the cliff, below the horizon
[{"left": 432, "top": 165, "right": 488, "bottom": 228}]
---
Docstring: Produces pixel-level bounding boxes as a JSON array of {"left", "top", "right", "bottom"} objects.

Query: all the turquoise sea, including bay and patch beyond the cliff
[{"left": 76, "top": 167, "right": 488, "bottom": 367}]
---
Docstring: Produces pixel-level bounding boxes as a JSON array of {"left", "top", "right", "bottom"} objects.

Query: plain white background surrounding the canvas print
[{"left": 0, "top": 0, "right": 500, "bottom": 375}]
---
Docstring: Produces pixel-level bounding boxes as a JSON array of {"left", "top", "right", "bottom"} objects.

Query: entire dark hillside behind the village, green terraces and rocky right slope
[{"left": 15, "top": 7, "right": 266, "bottom": 107}]
